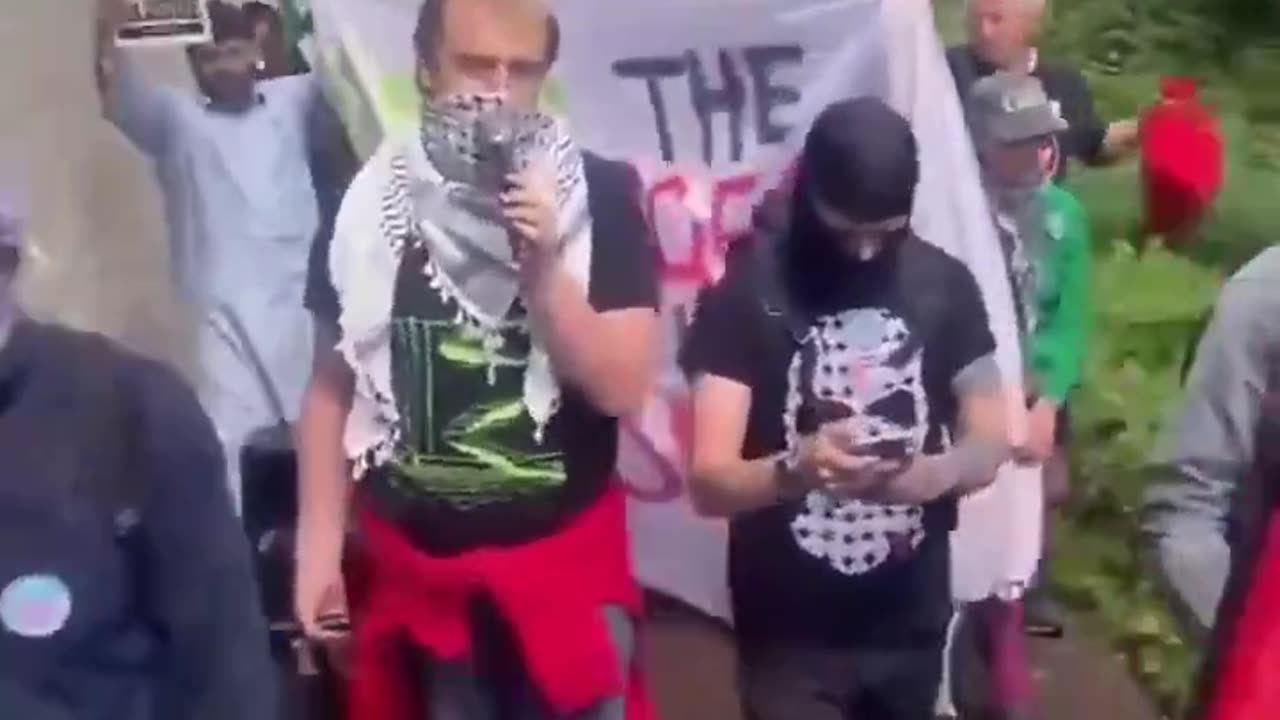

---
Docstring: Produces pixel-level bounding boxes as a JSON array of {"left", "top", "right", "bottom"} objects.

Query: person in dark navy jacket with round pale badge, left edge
[{"left": 0, "top": 188, "right": 275, "bottom": 720}]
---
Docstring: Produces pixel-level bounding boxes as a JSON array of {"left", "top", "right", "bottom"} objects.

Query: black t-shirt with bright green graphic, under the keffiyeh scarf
[{"left": 308, "top": 154, "right": 659, "bottom": 555}]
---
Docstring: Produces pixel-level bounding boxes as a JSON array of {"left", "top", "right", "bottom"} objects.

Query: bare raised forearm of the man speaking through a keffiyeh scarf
[{"left": 525, "top": 263, "right": 657, "bottom": 416}]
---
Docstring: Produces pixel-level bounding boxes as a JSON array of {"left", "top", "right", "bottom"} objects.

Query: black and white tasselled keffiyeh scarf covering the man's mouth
[{"left": 329, "top": 95, "right": 591, "bottom": 477}]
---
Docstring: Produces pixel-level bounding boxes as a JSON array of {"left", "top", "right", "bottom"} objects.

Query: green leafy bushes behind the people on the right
[{"left": 936, "top": 0, "right": 1280, "bottom": 716}]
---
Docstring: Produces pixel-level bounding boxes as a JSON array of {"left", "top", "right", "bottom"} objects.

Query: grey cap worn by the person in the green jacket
[{"left": 968, "top": 70, "right": 1068, "bottom": 142}]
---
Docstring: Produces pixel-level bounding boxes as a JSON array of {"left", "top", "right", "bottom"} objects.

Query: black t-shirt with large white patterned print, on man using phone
[{"left": 682, "top": 237, "right": 995, "bottom": 647}]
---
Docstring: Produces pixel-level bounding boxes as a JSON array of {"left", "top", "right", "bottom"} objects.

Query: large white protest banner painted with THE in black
[{"left": 310, "top": 0, "right": 1041, "bottom": 619}]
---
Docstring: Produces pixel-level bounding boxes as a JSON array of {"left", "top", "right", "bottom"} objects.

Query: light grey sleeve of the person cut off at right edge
[{"left": 1143, "top": 262, "right": 1280, "bottom": 632}]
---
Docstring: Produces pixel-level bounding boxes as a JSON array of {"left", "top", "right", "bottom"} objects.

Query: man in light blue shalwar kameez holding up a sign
[{"left": 99, "top": 0, "right": 328, "bottom": 507}]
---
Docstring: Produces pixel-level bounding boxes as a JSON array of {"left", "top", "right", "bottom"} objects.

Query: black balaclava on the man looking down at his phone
[{"left": 783, "top": 97, "right": 919, "bottom": 311}]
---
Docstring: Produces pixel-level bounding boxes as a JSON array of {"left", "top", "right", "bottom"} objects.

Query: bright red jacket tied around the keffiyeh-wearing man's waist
[{"left": 351, "top": 491, "right": 650, "bottom": 720}]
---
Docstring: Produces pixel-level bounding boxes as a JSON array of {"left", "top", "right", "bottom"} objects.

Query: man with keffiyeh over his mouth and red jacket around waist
[{"left": 296, "top": 0, "right": 658, "bottom": 720}]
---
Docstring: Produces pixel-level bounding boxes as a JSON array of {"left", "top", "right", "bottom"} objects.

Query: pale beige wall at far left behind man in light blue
[{"left": 0, "top": 0, "right": 197, "bottom": 365}]
